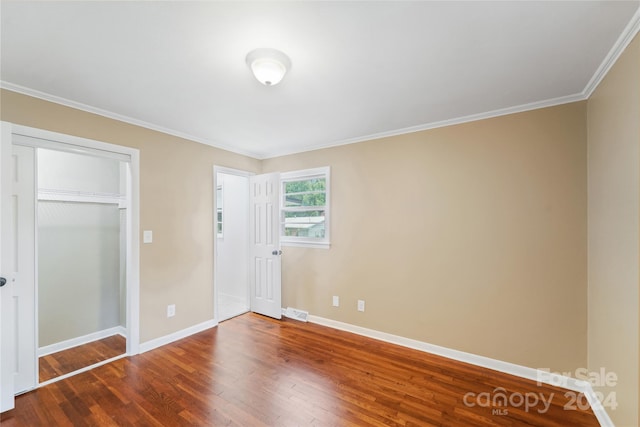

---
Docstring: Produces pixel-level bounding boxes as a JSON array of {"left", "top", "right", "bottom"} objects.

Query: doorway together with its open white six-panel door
[{"left": 213, "top": 166, "right": 282, "bottom": 322}]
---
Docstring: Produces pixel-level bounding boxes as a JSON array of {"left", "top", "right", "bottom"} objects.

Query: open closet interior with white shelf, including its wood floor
[{"left": 35, "top": 148, "right": 127, "bottom": 383}]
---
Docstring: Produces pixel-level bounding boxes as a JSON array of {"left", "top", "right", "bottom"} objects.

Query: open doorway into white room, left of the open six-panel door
[{"left": 213, "top": 166, "right": 252, "bottom": 322}]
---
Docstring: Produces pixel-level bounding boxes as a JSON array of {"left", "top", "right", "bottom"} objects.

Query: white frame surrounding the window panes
[{"left": 280, "top": 166, "right": 331, "bottom": 249}]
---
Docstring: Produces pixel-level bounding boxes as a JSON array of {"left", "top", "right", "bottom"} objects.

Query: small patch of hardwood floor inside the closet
[{"left": 38, "top": 335, "right": 127, "bottom": 383}]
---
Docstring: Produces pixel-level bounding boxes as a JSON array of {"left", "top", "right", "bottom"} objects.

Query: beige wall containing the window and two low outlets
[{"left": 263, "top": 102, "right": 587, "bottom": 371}]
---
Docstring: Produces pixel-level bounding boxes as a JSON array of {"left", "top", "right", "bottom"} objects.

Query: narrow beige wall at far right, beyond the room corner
[{"left": 587, "top": 37, "right": 640, "bottom": 426}]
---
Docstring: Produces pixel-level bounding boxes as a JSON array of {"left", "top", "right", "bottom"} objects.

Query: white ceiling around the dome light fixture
[{"left": 0, "top": 1, "right": 638, "bottom": 158}]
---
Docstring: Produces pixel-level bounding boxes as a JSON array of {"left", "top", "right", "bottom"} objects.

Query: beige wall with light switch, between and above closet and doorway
[{"left": 0, "top": 90, "right": 260, "bottom": 342}]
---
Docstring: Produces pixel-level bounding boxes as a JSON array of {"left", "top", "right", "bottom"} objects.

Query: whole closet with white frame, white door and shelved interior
[{"left": 0, "top": 122, "right": 140, "bottom": 411}]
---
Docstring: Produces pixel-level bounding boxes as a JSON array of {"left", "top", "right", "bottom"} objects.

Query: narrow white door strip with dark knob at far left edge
[{"left": 0, "top": 122, "right": 15, "bottom": 412}]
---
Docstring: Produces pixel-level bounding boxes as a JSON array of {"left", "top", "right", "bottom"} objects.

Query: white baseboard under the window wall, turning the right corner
[{"left": 309, "top": 315, "right": 613, "bottom": 427}]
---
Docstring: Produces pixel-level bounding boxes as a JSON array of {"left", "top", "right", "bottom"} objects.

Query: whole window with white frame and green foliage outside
[{"left": 280, "top": 167, "right": 329, "bottom": 247}]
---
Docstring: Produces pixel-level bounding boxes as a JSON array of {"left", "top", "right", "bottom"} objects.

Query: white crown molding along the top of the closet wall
[{"left": 0, "top": 80, "right": 260, "bottom": 159}]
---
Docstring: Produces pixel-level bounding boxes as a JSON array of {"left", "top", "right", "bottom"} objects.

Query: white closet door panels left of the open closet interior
[{"left": 0, "top": 138, "right": 37, "bottom": 410}]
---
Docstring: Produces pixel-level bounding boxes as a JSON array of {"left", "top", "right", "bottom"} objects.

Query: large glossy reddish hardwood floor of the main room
[{"left": 1, "top": 313, "right": 598, "bottom": 427}]
